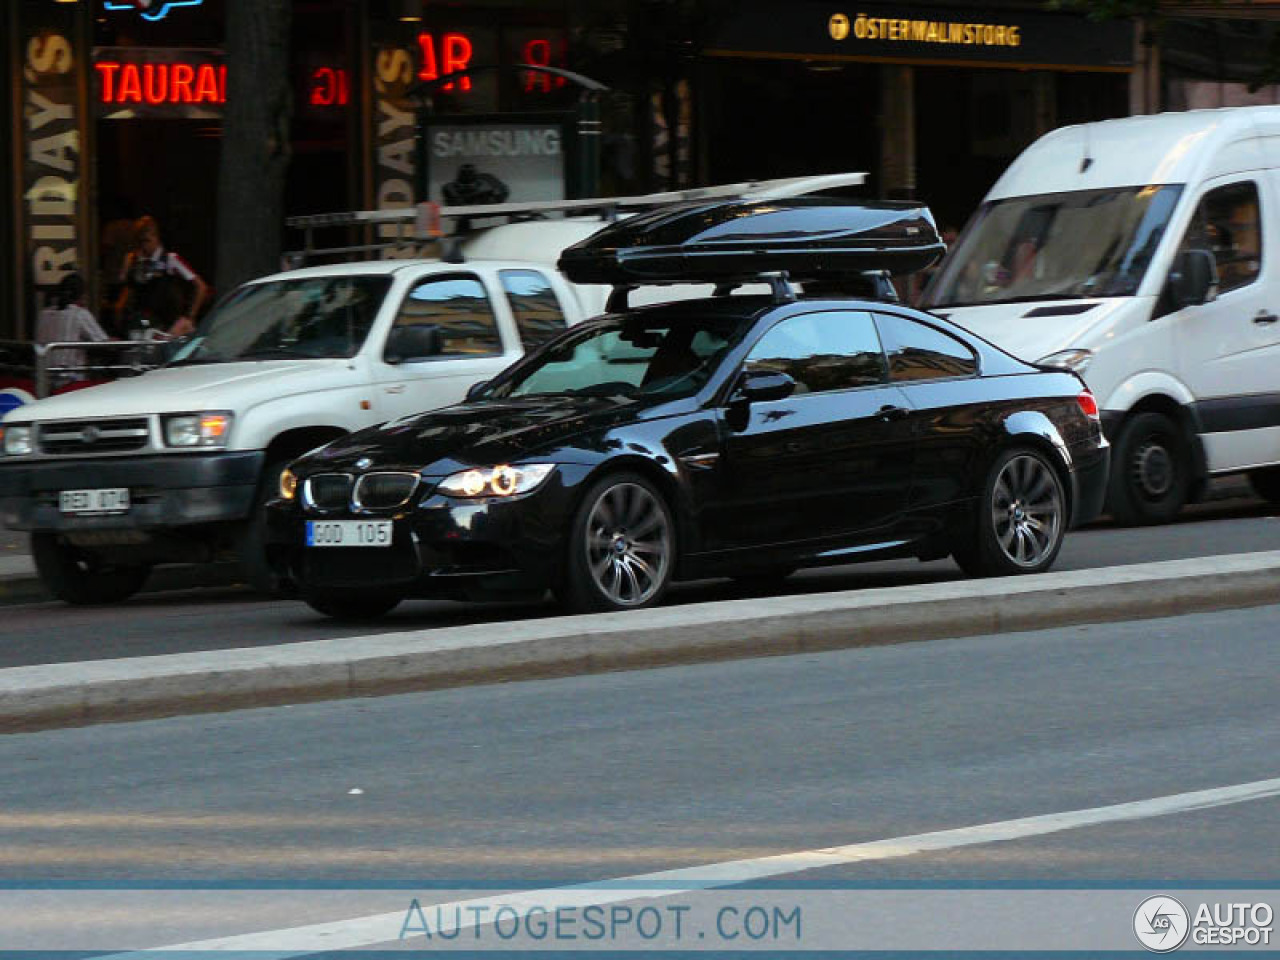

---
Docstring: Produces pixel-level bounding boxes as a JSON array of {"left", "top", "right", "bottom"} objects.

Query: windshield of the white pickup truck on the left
[{"left": 170, "top": 276, "right": 390, "bottom": 366}]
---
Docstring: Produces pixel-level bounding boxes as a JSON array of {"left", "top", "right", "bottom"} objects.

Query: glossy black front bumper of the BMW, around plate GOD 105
[{"left": 266, "top": 466, "right": 585, "bottom": 599}]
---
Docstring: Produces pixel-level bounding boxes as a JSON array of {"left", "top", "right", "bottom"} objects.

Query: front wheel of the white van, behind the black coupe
[{"left": 1107, "top": 412, "right": 1192, "bottom": 526}]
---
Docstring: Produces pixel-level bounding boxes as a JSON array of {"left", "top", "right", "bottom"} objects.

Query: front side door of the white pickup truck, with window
[{"left": 372, "top": 270, "right": 521, "bottom": 420}]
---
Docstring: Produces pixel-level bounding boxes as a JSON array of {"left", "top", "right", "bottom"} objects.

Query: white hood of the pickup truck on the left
[{"left": 12, "top": 360, "right": 351, "bottom": 420}]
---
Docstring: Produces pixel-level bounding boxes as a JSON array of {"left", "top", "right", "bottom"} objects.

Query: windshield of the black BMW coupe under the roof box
[{"left": 486, "top": 315, "right": 751, "bottom": 399}]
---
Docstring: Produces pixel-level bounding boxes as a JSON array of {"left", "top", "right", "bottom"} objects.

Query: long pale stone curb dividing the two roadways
[{"left": 0, "top": 552, "right": 1280, "bottom": 732}]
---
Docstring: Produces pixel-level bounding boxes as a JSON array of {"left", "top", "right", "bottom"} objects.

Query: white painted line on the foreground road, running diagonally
[{"left": 99, "top": 777, "right": 1280, "bottom": 960}]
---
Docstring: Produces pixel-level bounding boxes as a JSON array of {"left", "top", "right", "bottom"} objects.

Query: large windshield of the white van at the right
[{"left": 924, "top": 186, "right": 1183, "bottom": 307}]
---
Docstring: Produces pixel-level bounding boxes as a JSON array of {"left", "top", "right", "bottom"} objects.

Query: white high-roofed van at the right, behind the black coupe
[{"left": 924, "top": 106, "right": 1280, "bottom": 524}]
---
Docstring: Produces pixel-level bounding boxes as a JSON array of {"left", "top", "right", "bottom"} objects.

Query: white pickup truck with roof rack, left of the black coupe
[{"left": 0, "top": 174, "right": 863, "bottom": 603}]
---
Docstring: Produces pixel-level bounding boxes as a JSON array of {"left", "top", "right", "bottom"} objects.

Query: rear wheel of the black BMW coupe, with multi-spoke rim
[{"left": 952, "top": 447, "right": 1070, "bottom": 576}]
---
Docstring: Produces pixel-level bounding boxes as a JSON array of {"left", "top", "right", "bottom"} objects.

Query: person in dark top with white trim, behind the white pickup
[{"left": 115, "top": 216, "right": 209, "bottom": 340}]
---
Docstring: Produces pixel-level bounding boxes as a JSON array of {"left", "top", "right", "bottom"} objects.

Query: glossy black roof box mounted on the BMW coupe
[{"left": 559, "top": 196, "right": 946, "bottom": 285}]
